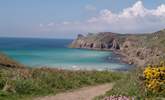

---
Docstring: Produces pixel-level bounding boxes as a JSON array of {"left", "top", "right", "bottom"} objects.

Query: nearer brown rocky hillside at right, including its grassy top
[{"left": 120, "top": 30, "right": 165, "bottom": 66}]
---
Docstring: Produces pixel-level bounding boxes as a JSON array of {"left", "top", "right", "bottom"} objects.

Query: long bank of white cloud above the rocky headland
[{"left": 39, "top": 1, "right": 165, "bottom": 33}]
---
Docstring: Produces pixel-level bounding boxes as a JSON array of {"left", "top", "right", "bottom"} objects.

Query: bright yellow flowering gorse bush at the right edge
[{"left": 143, "top": 62, "right": 165, "bottom": 93}]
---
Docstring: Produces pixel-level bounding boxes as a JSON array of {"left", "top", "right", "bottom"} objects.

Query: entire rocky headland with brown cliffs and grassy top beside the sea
[{"left": 69, "top": 29, "right": 165, "bottom": 66}]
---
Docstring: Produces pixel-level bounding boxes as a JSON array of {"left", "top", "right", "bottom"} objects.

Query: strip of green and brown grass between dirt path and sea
[{"left": 0, "top": 68, "right": 123, "bottom": 100}]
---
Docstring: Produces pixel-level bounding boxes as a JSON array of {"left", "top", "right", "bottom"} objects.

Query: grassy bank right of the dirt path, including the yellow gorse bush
[{"left": 95, "top": 63, "right": 165, "bottom": 100}]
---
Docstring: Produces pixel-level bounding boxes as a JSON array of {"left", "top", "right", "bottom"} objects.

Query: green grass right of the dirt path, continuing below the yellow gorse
[{"left": 94, "top": 68, "right": 165, "bottom": 100}]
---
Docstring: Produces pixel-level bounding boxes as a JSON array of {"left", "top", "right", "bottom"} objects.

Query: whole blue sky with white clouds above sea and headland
[{"left": 0, "top": 0, "right": 165, "bottom": 38}]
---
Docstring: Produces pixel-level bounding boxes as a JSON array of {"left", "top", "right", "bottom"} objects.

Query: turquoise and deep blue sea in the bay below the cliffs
[{"left": 0, "top": 38, "right": 131, "bottom": 70}]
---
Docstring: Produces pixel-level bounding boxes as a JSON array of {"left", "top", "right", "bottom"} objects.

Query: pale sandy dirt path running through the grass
[{"left": 35, "top": 84, "right": 113, "bottom": 100}]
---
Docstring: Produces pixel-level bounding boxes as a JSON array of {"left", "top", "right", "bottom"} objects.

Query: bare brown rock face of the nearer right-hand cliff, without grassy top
[{"left": 120, "top": 37, "right": 165, "bottom": 66}]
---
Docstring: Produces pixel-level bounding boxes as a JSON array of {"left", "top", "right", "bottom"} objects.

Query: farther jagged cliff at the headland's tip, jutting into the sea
[{"left": 70, "top": 32, "right": 120, "bottom": 50}]
